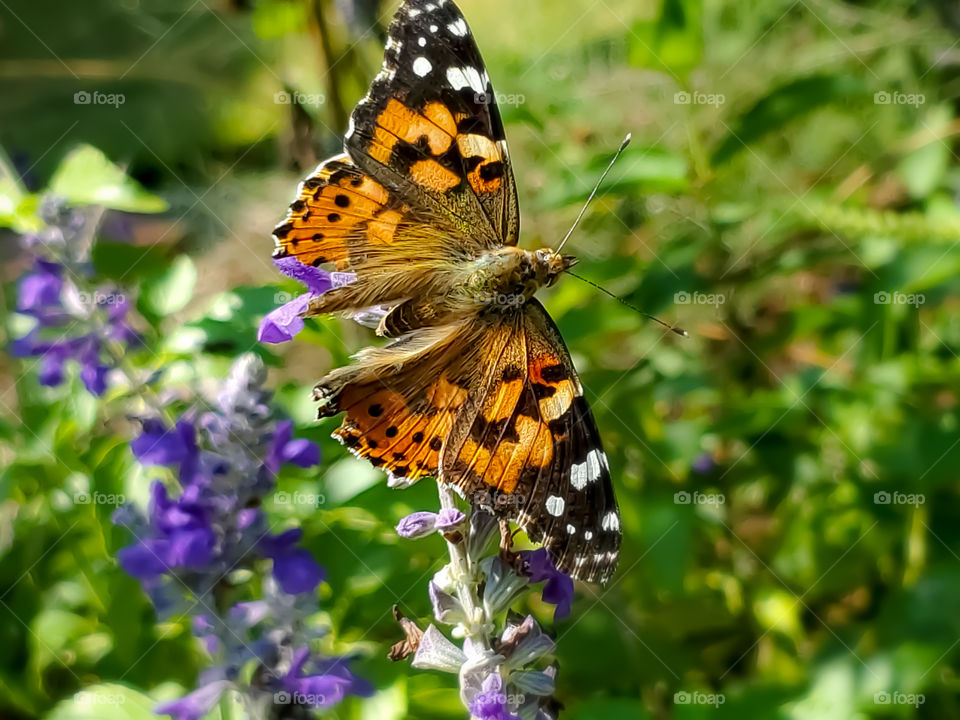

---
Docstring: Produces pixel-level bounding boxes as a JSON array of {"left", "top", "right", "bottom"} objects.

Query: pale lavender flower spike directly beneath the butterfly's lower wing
[{"left": 397, "top": 484, "right": 573, "bottom": 720}]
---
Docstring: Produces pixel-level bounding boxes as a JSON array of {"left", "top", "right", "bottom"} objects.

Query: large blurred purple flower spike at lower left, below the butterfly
[{"left": 115, "top": 355, "right": 368, "bottom": 720}]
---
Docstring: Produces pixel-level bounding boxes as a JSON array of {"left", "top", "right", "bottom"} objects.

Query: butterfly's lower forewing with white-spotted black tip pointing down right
[{"left": 440, "top": 300, "right": 620, "bottom": 582}]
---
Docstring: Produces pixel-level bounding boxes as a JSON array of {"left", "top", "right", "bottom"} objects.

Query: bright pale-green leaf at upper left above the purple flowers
[{"left": 48, "top": 145, "right": 167, "bottom": 213}]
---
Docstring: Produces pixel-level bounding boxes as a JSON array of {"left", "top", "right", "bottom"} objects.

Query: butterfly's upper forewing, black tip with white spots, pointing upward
[{"left": 345, "top": 0, "right": 520, "bottom": 248}]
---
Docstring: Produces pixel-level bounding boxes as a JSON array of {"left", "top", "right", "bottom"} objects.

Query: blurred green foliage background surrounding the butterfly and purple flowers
[{"left": 0, "top": 0, "right": 960, "bottom": 720}]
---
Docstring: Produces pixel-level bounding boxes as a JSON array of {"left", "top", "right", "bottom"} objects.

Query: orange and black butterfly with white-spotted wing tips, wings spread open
[{"left": 274, "top": 0, "right": 621, "bottom": 582}]
